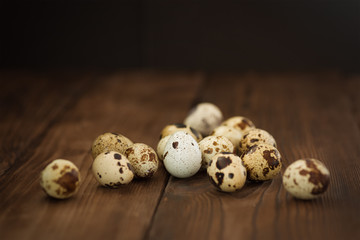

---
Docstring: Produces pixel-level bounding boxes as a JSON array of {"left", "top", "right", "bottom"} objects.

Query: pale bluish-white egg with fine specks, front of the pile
[{"left": 164, "top": 131, "right": 201, "bottom": 178}]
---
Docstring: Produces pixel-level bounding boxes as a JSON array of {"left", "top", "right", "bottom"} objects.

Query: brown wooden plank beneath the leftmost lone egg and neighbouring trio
[{"left": 0, "top": 72, "right": 202, "bottom": 239}]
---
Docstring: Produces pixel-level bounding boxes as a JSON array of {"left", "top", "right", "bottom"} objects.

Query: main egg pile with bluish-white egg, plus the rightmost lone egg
[{"left": 156, "top": 103, "right": 329, "bottom": 199}]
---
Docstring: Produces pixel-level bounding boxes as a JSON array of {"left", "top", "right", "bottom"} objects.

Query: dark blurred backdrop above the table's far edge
[{"left": 0, "top": 0, "right": 360, "bottom": 73}]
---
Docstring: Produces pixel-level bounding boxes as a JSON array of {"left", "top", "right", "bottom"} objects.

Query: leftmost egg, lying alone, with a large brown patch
[{"left": 40, "top": 159, "right": 80, "bottom": 199}]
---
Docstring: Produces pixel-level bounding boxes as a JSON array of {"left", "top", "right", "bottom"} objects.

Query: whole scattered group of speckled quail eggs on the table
[{"left": 40, "top": 102, "right": 330, "bottom": 199}]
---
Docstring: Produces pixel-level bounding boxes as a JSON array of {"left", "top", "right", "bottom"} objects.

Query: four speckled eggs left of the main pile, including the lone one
[{"left": 40, "top": 133, "right": 159, "bottom": 199}]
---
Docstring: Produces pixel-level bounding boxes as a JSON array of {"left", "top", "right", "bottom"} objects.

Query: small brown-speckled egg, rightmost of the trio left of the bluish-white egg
[{"left": 125, "top": 143, "right": 159, "bottom": 178}]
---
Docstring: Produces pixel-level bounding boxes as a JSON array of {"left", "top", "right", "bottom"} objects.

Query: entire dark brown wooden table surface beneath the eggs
[{"left": 0, "top": 71, "right": 360, "bottom": 240}]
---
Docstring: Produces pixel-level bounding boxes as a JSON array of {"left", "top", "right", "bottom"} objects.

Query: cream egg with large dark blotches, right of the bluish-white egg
[{"left": 207, "top": 152, "right": 247, "bottom": 192}]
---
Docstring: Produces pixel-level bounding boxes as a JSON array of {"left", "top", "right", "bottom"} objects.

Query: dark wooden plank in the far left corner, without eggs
[{"left": 0, "top": 71, "right": 89, "bottom": 176}]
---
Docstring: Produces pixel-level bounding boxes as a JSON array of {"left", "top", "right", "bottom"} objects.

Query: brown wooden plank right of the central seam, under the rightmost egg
[{"left": 148, "top": 74, "right": 360, "bottom": 239}]
